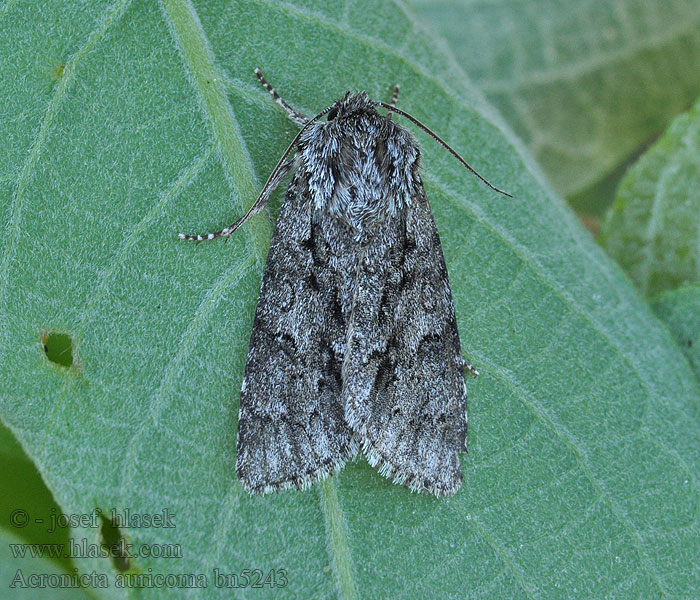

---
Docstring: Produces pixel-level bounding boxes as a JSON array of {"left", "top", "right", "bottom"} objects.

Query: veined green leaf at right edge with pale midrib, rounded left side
[{"left": 600, "top": 94, "right": 700, "bottom": 296}]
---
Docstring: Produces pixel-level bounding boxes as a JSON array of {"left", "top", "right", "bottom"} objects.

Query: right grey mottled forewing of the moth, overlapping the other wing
[{"left": 343, "top": 184, "right": 467, "bottom": 496}]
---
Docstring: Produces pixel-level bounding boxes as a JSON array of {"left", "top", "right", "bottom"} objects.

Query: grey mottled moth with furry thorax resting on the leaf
[{"left": 180, "top": 69, "right": 509, "bottom": 496}]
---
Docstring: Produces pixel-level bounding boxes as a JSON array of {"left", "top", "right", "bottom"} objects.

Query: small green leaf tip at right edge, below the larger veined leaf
[{"left": 652, "top": 285, "right": 700, "bottom": 380}]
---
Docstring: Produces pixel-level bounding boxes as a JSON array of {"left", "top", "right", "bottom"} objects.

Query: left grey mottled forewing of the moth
[{"left": 236, "top": 169, "right": 357, "bottom": 493}]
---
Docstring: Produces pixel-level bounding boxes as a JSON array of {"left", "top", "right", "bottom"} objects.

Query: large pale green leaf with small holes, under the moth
[{"left": 0, "top": 0, "right": 700, "bottom": 599}]
